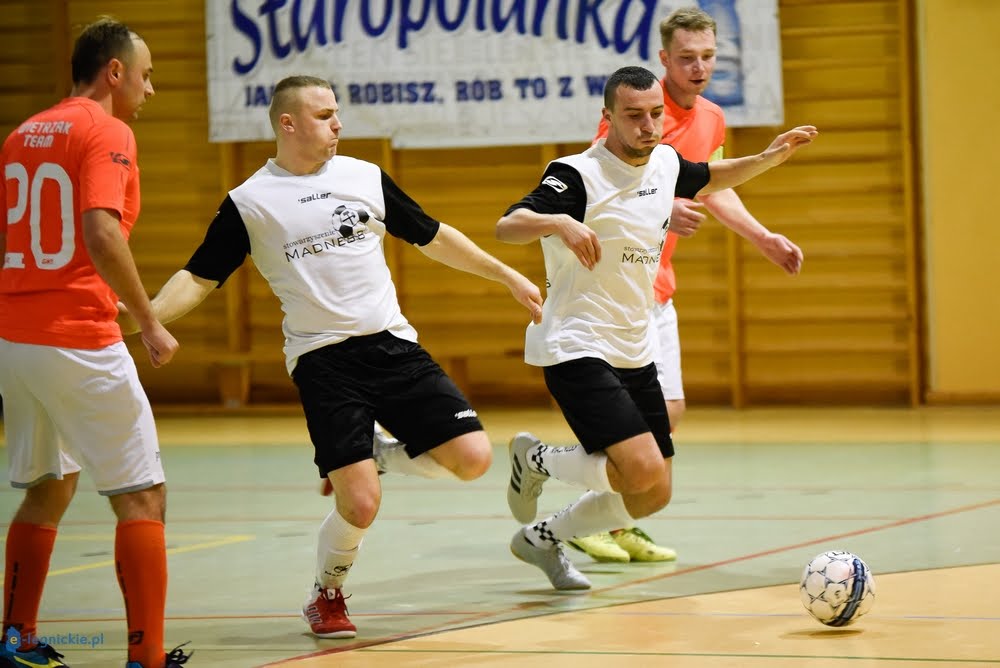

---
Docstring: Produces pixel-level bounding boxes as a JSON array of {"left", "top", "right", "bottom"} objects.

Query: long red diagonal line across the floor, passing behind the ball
[{"left": 260, "top": 498, "right": 1000, "bottom": 668}]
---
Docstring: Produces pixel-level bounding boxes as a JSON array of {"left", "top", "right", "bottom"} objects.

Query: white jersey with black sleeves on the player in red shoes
[{"left": 185, "top": 156, "right": 440, "bottom": 373}]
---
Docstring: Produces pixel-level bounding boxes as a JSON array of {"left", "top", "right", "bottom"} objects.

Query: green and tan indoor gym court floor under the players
[{"left": 0, "top": 407, "right": 1000, "bottom": 668}]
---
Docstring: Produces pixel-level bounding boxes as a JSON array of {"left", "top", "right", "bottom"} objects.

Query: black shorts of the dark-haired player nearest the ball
[{"left": 544, "top": 357, "right": 674, "bottom": 458}]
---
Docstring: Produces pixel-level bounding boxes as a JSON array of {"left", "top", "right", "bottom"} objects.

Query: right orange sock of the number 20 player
[{"left": 115, "top": 520, "right": 167, "bottom": 668}]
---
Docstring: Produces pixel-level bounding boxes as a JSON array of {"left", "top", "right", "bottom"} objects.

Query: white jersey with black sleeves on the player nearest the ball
[{"left": 508, "top": 139, "right": 709, "bottom": 369}]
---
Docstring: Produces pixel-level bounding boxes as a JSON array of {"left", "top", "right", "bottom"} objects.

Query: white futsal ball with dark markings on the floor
[{"left": 799, "top": 550, "right": 875, "bottom": 626}]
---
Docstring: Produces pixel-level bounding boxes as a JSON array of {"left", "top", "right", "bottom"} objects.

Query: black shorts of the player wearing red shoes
[{"left": 292, "top": 332, "right": 483, "bottom": 478}]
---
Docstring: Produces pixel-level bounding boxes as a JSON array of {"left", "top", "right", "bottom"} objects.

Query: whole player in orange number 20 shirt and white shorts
[{"left": 0, "top": 18, "right": 187, "bottom": 668}]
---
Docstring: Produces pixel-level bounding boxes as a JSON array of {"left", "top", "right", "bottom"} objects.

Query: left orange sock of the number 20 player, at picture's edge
[{"left": 0, "top": 522, "right": 56, "bottom": 649}]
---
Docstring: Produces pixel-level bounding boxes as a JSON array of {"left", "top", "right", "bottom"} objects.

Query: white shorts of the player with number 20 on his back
[{"left": 0, "top": 338, "right": 164, "bottom": 496}]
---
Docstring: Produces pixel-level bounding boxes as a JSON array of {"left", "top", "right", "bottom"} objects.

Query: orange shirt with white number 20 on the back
[{"left": 0, "top": 97, "right": 139, "bottom": 349}]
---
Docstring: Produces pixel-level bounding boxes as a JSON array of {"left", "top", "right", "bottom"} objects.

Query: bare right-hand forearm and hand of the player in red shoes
[{"left": 418, "top": 223, "right": 542, "bottom": 324}]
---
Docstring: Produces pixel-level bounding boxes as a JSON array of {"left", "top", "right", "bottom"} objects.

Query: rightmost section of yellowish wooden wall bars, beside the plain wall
[{"left": 720, "top": 0, "right": 920, "bottom": 403}]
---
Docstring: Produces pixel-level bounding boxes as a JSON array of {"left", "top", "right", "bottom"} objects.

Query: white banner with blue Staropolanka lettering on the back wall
[{"left": 205, "top": 0, "right": 783, "bottom": 147}]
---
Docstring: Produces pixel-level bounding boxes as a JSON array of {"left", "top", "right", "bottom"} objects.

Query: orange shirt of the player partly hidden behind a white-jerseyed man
[{"left": 594, "top": 81, "right": 726, "bottom": 304}]
